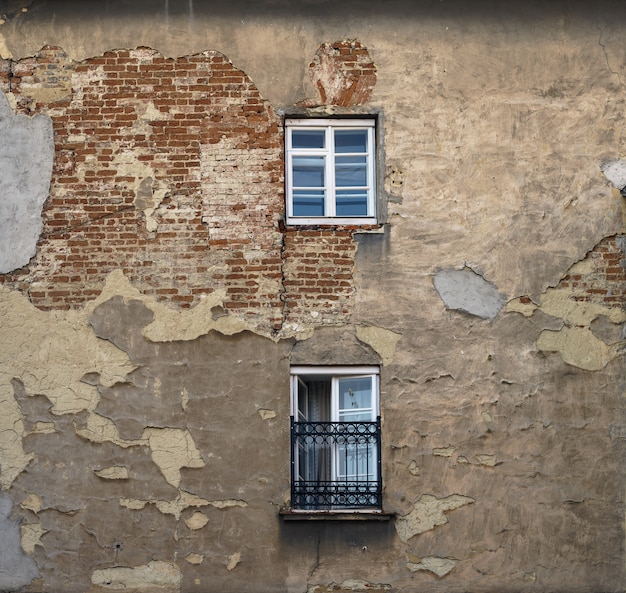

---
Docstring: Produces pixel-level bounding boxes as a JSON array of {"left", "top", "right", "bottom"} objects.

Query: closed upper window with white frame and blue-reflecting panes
[{"left": 285, "top": 118, "right": 376, "bottom": 224}]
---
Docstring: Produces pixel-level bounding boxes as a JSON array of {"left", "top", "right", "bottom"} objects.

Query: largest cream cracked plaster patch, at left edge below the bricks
[{"left": 0, "top": 287, "right": 135, "bottom": 489}]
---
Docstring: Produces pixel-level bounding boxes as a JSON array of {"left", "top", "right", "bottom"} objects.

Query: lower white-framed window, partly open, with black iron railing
[{"left": 291, "top": 366, "right": 382, "bottom": 511}]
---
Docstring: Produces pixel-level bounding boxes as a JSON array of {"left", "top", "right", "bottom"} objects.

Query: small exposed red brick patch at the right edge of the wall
[{"left": 557, "top": 235, "right": 626, "bottom": 308}]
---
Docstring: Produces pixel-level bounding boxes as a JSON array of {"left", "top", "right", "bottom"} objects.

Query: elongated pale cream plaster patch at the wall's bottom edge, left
[{"left": 88, "top": 560, "right": 182, "bottom": 593}]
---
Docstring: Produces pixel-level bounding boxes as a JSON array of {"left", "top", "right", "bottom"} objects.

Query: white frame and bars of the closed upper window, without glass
[{"left": 285, "top": 118, "right": 377, "bottom": 225}]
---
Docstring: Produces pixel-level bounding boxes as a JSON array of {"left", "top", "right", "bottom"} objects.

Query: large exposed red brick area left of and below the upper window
[{"left": 0, "top": 44, "right": 369, "bottom": 331}]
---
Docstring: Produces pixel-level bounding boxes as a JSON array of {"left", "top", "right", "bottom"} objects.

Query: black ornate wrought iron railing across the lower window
[{"left": 291, "top": 417, "right": 382, "bottom": 510}]
